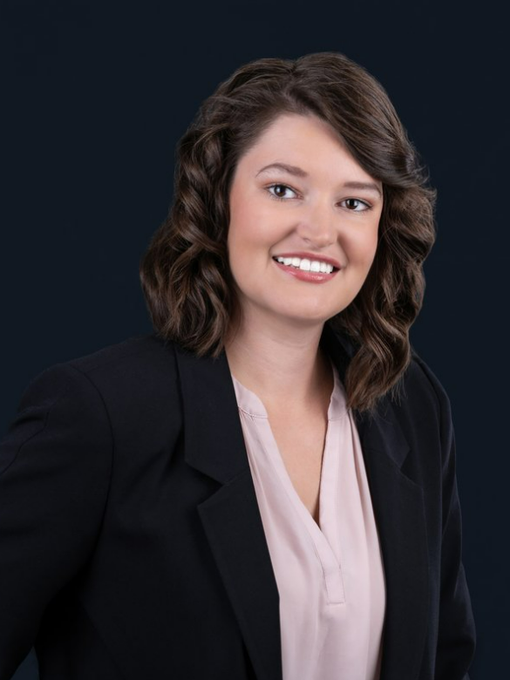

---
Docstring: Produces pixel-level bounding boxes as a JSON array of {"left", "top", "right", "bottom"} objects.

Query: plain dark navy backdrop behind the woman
[{"left": 0, "top": 0, "right": 510, "bottom": 680}]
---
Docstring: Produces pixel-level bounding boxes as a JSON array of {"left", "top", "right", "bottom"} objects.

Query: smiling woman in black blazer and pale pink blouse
[{"left": 0, "top": 52, "right": 475, "bottom": 680}]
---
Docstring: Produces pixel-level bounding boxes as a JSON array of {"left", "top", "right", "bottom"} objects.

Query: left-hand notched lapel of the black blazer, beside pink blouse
[{"left": 175, "top": 345, "right": 282, "bottom": 680}]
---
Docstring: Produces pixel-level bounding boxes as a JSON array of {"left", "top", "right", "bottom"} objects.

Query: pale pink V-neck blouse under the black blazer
[{"left": 232, "top": 364, "right": 386, "bottom": 680}]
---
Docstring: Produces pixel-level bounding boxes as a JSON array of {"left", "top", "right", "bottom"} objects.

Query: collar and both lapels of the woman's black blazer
[{"left": 175, "top": 324, "right": 428, "bottom": 680}]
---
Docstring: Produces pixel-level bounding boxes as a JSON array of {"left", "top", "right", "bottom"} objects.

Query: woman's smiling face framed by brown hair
[{"left": 227, "top": 114, "right": 383, "bottom": 334}]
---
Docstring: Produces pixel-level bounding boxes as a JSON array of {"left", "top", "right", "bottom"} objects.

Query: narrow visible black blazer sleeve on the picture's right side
[{"left": 417, "top": 358, "right": 476, "bottom": 680}]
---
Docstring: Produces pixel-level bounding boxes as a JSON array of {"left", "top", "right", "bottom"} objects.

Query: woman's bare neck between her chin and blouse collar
[{"left": 225, "top": 310, "right": 333, "bottom": 410}]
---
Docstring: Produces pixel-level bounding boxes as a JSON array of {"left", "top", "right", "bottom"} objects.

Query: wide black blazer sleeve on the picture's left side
[{"left": 0, "top": 364, "right": 112, "bottom": 680}]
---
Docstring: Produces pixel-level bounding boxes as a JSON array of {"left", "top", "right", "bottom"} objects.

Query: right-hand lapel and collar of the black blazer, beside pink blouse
[{"left": 323, "top": 324, "right": 429, "bottom": 680}]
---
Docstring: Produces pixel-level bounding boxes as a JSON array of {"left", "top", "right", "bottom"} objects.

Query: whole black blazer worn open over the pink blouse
[{"left": 0, "top": 324, "right": 475, "bottom": 680}]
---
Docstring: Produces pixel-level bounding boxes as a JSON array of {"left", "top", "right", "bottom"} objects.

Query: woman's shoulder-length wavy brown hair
[{"left": 140, "top": 52, "right": 436, "bottom": 413}]
